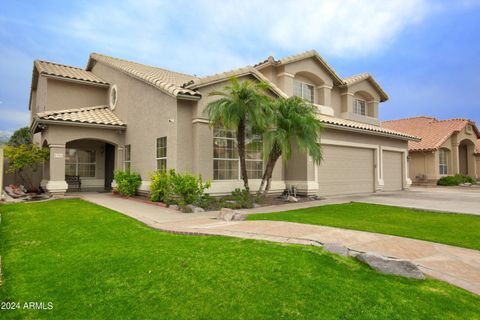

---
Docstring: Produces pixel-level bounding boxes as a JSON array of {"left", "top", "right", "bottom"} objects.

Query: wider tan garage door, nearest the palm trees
[{"left": 318, "top": 146, "right": 375, "bottom": 195}]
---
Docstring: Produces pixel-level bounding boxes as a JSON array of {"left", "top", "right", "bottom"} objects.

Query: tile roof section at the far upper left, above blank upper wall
[{"left": 34, "top": 60, "right": 108, "bottom": 85}]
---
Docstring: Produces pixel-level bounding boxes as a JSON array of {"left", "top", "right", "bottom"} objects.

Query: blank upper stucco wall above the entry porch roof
[{"left": 45, "top": 79, "right": 108, "bottom": 110}]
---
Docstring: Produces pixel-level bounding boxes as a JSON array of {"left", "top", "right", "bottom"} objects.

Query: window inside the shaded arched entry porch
[{"left": 65, "top": 148, "right": 96, "bottom": 178}]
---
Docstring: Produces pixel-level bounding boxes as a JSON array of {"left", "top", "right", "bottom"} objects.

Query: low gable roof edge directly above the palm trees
[{"left": 184, "top": 66, "right": 287, "bottom": 98}]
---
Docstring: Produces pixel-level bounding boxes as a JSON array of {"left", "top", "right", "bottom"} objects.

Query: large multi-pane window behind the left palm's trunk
[{"left": 213, "top": 128, "right": 263, "bottom": 180}]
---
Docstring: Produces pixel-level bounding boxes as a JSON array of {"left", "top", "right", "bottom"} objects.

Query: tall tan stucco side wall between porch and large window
[{"left": 92, "top": 62, "right": 178, "bottom": 181}]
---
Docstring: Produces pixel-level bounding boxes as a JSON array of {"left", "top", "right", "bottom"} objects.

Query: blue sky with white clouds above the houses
[{"left": 0, "top": 0, "right": 480, "bottom": 132}]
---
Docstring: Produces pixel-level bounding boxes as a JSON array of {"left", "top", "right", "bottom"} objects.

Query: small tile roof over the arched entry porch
[{"left": 35, "top": 106, "right": 126, "bottom": 127}]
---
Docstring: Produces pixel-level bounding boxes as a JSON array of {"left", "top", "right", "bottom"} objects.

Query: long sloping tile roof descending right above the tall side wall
[{"left": 87, "top": 53, "right": 200, "bottom": 97}]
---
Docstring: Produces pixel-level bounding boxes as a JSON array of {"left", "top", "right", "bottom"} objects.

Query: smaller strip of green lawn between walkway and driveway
[{"left": 248, "top": 202, "right": 480, "bottom": 250}]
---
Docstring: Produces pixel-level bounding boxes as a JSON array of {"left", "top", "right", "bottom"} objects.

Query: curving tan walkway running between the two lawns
[{"left": 80, "top": 193, "right": 480, "bottom": 294}]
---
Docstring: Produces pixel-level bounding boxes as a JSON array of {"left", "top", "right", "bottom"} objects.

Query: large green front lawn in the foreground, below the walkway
[{"left": 0, "top": 199, "right": 480, "bottom": 319}]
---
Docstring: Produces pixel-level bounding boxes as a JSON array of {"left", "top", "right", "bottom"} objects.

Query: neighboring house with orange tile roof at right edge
[{"left": 382, "top": 117, "right": 480, "bottom": 183}]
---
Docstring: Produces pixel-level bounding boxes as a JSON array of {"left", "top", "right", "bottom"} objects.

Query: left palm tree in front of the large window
[{"left": 204, "top": 77, "right": 272, "bottom": 191}]
